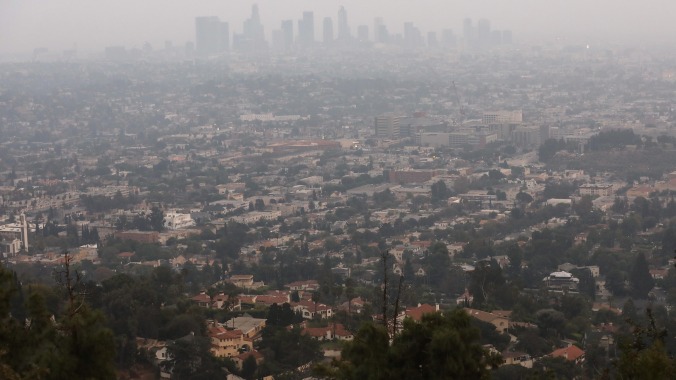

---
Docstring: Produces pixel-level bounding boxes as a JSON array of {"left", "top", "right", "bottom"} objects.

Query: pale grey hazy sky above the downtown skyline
[{"left": 0, "top": 0, "right": 676, "bottom": 53}]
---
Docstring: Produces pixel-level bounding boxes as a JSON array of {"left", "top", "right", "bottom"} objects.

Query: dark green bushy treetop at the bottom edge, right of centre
[{"left": 324, "top": 309, "right": 501, "bottom": 380}]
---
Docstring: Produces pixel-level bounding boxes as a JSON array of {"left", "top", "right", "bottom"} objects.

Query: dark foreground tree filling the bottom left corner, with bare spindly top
[{"left": 0, "top": 254, "right": 116, "bottom": 380}]
